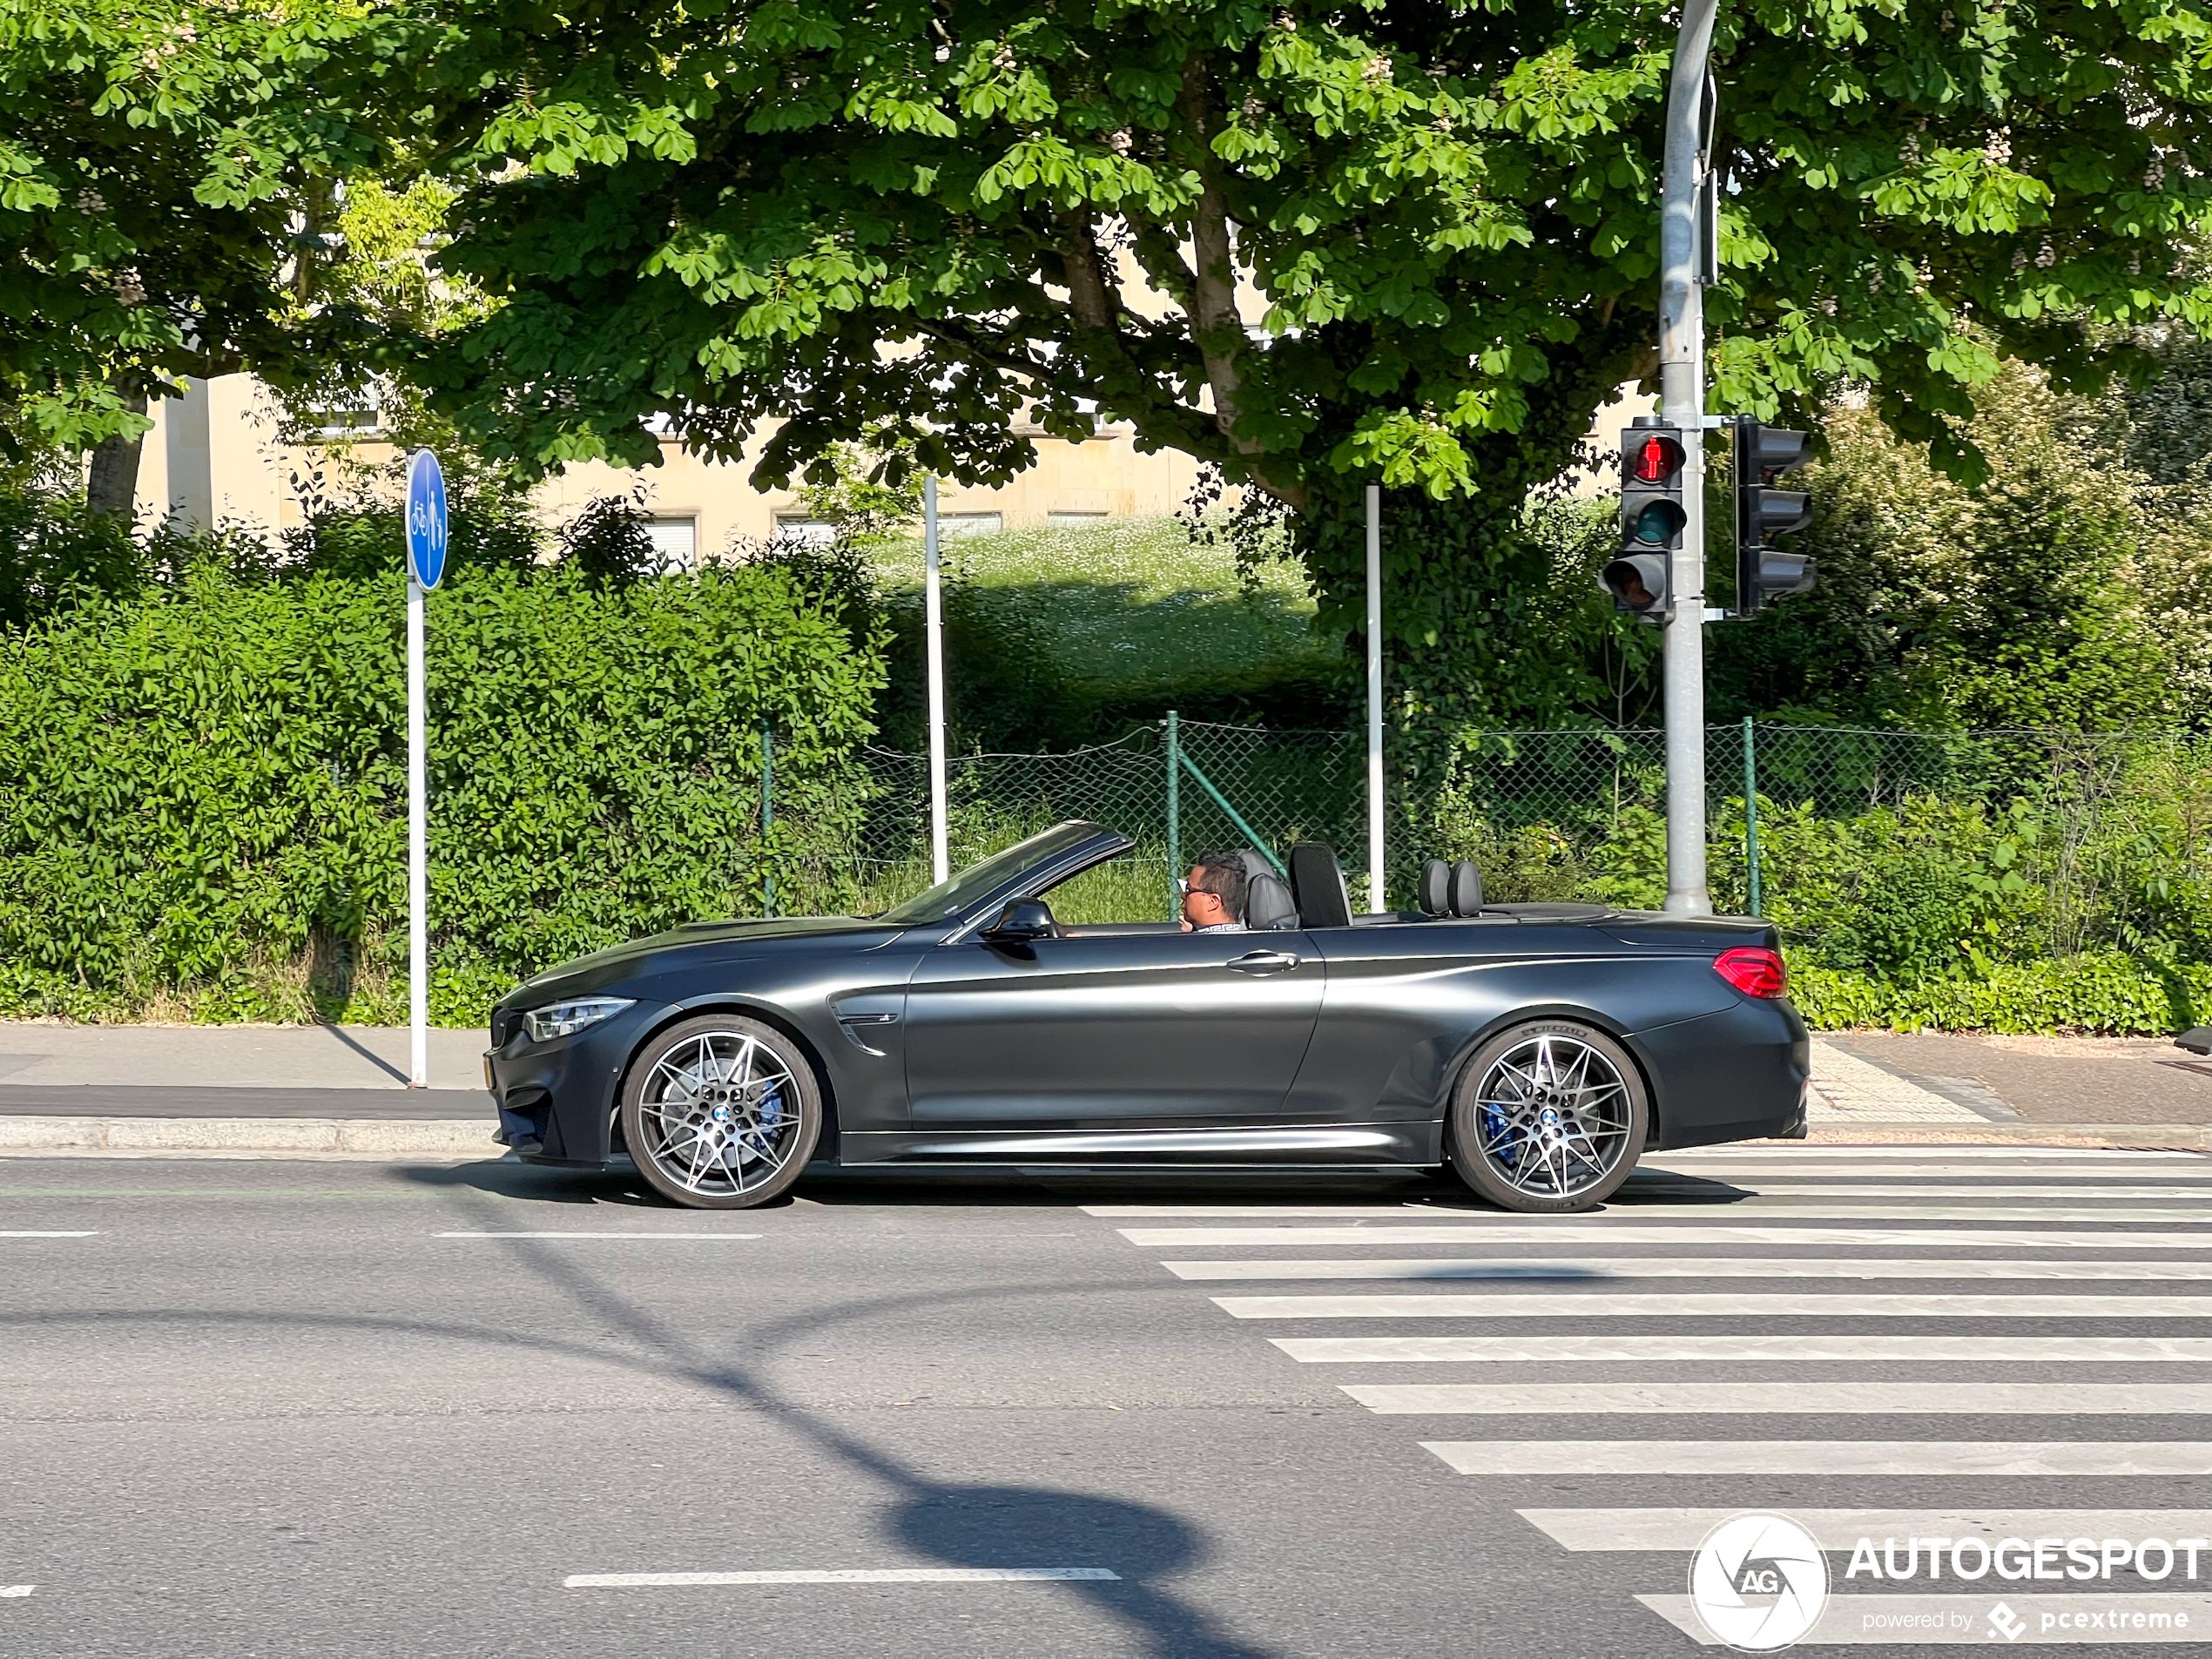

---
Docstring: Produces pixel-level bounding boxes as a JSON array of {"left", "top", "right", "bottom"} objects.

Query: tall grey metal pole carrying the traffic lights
[{"left": 1659, "top": 0, "right": 1719, "bottom": 916}]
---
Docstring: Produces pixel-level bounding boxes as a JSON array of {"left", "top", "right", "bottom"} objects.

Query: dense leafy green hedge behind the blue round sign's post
[{"left": 0, "top": 560, "right": 882, "bottom": 1024}]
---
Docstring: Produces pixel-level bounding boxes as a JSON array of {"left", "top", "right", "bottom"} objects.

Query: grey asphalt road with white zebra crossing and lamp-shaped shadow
[{"left": 0, "top": 1148, "right": 2212, "bottom": 1659}]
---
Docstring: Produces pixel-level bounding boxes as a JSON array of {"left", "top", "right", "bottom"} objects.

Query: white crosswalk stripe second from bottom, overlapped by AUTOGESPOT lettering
[{"left": 1515, "top": 1508, "right": 2212, "bottom": 1557}]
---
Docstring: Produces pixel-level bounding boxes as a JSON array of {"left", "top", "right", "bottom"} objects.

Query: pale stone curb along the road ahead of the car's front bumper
[{"left": 0, "top": 1117, "right": 507, "bottom": 1162}]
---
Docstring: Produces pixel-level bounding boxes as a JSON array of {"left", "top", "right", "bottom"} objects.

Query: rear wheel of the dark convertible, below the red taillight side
[{"left": 1447, "top": 1020, "right": 1650, "bottom": 1214}]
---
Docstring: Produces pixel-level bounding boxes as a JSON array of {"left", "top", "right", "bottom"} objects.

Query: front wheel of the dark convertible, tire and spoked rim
[{"left": 622, "top": 1013, "right": 823, "bottom": 1210}]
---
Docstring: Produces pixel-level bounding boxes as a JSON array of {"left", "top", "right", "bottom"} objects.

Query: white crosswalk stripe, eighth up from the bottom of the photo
[{"left": 1119, "top": 1210, "right": 2212, "bottom": 1250}]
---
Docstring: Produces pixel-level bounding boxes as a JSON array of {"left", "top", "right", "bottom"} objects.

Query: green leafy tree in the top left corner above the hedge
[{"left": 0, "top": 0, "right": 381, "bottom": 511}]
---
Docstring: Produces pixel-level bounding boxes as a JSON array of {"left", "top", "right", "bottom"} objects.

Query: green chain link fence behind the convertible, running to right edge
[{"left": 756, "top": 717, "right": 2212, "bottom": 974}]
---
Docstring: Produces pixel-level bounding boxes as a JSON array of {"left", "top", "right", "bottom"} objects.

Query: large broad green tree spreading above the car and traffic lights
[{"left": 389, "top": 0, "right": 2212, "bottom": 777}]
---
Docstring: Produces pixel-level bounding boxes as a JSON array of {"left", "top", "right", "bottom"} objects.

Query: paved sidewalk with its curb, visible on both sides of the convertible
[{"left": 0, "top": 1022, "right": 2212, "bottom": 1159}]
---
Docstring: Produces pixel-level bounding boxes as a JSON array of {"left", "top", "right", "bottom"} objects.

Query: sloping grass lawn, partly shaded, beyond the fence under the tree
[{"left": 876, "top": 517, "right": 1339, "bottom": 697}]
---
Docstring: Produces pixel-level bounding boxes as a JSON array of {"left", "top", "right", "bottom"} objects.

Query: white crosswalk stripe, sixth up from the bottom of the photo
[{"left": 1214, "top": 1290, "right": 2212, "bottom": 1318}]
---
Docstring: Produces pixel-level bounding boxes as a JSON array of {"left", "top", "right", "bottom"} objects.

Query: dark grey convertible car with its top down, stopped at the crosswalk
[{"left": 484, "top": 823, "right": 1807, "bottom": 1212}]
